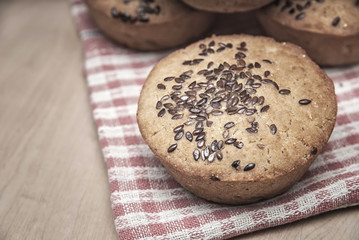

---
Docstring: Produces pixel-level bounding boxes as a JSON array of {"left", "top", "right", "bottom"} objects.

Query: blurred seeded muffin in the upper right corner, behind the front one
[{"left": 258, "top": 0, "right": 359, "bottom": 66}]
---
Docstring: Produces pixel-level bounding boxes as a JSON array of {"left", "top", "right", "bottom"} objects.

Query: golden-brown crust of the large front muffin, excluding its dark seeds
[{"left": 137, "top": 35, "right": 337, "bottom": 204}]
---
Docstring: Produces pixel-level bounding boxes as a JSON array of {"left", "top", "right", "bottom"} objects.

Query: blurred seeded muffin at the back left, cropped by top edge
[{"left": 86, "top": 0, "right": 214, "bottom": 50}]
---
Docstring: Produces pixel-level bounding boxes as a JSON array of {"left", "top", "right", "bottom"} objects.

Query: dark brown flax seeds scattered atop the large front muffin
[{"left": 154, "top": 41, "right": 311, "bottom": 171}]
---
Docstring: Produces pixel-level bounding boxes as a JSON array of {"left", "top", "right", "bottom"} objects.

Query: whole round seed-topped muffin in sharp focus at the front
[{"left": 137, "top": 35, "right": 337, "bottom": 204}]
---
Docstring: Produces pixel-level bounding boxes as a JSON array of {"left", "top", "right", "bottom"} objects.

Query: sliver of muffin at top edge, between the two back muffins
[{"left": 182, "top": 0, "right": 273, "bottom": 13}]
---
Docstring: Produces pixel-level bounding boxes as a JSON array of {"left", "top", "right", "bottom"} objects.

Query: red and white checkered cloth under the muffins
[{"left": 71, "top": 0, "right": 359, "bottom": 239}]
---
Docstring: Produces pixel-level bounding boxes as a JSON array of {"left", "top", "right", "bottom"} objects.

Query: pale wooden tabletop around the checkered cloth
[{"left": 0, "top": 0, "right": 359, "bottom": 239}]
